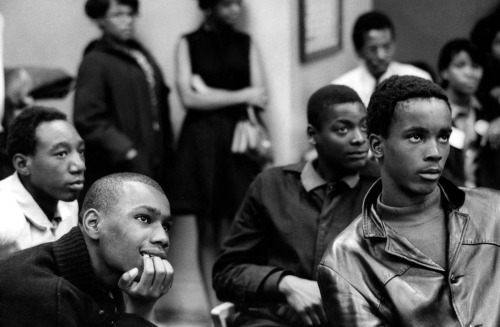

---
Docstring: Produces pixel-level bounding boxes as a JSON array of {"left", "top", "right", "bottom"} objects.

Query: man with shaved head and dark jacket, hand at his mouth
[{"left": 0, "top": 173, "right": 173, "bottom": 327}]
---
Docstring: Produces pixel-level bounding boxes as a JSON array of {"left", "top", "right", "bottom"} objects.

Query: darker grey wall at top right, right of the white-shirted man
[{"left": 373, "top": 0, "right": 498, "bottom": 76}]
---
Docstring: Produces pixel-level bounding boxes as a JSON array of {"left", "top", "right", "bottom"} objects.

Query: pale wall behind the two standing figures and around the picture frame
[{"left": 0, "top": 0, "right": 372, "bottom": 164}]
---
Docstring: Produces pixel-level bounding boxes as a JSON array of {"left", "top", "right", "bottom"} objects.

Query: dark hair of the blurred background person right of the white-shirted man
[{"left": 438, "top": 39, "right": 485, "bottom": 87}]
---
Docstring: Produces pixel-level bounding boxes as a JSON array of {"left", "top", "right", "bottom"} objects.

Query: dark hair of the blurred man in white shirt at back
[{"left": 352, "top": 10, "right": 396, "bottom": 52}]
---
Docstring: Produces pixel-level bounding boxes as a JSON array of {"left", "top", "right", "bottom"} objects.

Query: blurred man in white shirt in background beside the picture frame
[{"left": 332, "top": 11, "right": 431, "bottom": 106}]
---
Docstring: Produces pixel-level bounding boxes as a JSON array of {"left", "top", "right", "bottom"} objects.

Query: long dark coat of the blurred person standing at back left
[{"left": 74, "top": 38, "right": 172, "bottom": 192}]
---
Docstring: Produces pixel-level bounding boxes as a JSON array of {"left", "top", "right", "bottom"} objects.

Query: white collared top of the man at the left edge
[{"left": 0, "top": 173, "right": 78, "bottom": 258}]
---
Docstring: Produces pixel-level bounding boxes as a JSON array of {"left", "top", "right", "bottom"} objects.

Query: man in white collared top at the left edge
[{"left": 0, "top": 107, "right": 85, "bottom": 258}]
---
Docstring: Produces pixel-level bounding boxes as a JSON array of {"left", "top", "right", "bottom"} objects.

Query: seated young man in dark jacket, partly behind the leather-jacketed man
[{"left": 213, "top": 85, "right": 378, "bottom": 326}]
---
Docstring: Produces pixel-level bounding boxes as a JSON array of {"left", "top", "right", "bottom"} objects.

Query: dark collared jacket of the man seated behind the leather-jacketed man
[{"left": 213, "top": 161, "right": 378, "bottom": 307}]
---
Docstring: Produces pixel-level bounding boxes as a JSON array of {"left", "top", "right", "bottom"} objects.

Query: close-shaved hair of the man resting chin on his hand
[{"left": 78, "top": 173, "right": 165, "bottom": 223}]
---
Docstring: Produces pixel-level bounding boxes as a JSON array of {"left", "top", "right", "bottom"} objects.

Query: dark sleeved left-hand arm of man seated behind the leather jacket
[{"left": 213, "top": 175, "right": 285, "bottom": 306}]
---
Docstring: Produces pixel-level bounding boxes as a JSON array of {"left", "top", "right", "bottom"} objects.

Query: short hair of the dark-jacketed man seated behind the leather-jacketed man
[{"left": 307, "top": 84, "right": 363, "bottom": 129}]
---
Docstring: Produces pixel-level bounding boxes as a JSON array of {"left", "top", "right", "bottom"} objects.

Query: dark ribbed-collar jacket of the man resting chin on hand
[{"left": 0, "top": 227, "right": 155, "bottom": 327}]
